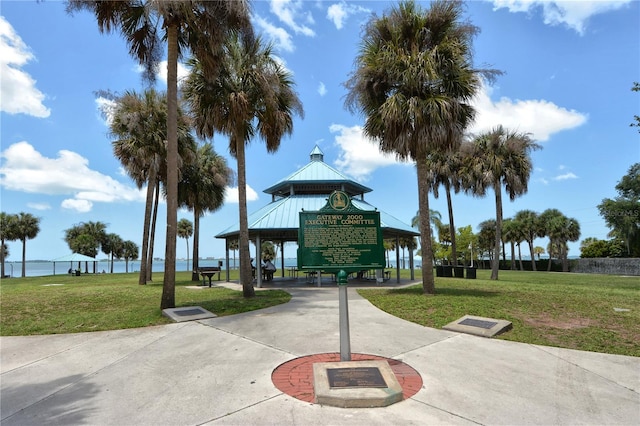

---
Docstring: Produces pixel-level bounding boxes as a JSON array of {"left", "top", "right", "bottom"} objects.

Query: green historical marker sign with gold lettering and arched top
[{"left": 298, "top": 191, "right": 385, "bottom": 272}]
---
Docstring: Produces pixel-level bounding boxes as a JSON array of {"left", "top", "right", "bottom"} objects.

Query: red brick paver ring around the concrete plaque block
[{"left": 271, "top": 352, "right": 422, "bottom": 402}]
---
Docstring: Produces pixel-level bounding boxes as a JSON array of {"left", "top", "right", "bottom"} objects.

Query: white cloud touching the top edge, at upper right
[{"left": 493, "top": 0, "right": 632, "bottom": 35}]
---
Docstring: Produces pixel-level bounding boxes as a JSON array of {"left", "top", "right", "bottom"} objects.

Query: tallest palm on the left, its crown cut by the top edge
[{"left": 67, "top": 0, "right": 252, "bottom": 309}]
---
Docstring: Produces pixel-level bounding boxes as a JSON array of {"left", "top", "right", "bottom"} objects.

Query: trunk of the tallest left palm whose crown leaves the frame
[{"left": 160, "top": 22, "right": 178, "bottom": 309}]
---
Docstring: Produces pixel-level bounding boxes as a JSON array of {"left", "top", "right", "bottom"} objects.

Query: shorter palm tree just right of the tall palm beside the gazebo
[{"left": 463, "top": 126, "right": 540, "bottom": 280}]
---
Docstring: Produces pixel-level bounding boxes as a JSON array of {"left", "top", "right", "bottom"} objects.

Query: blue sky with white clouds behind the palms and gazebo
[{"left": 0, "top": 0, "right": 640, "bottom": 261}]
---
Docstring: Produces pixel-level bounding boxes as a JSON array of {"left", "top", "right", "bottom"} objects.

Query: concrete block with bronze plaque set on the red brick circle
[{"left": 313, "top": 361, "right": 402, "bottom": 408}]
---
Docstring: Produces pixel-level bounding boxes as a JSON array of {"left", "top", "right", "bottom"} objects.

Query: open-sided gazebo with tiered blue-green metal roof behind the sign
[{"left": 215, "top": 145, "right": 420, "bottom": 287}]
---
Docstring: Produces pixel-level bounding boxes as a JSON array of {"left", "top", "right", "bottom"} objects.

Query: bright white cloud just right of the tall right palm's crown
[{"left": 469, "top": 86, "right": 588, "bottom": 142}]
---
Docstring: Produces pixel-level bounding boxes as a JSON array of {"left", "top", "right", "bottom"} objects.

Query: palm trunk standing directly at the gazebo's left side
[{"left": 232, "top": 136, "right": 254, "bottom": 297}]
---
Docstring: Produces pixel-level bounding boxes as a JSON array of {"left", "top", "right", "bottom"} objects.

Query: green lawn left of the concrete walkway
[{"left": 0, "top": 272, "right": 291, "bottom": 336}]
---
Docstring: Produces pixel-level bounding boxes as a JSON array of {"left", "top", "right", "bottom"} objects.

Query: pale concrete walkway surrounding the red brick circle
[{"left": 0, "top": 284, "right": 640, "bottom": 426}]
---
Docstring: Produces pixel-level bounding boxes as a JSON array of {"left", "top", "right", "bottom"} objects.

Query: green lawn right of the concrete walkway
[{"left": 359, "top": 270, "right": 640, "bottom": 356}]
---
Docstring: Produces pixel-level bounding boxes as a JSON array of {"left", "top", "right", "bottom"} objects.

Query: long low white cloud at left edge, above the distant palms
[{"left": 0, "top": 141, "right": 145, "bottom": 211}]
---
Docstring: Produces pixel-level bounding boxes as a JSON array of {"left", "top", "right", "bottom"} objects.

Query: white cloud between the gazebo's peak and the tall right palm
[{"left": 329, "top": 124, "right": 411, "bottom": 181}]
